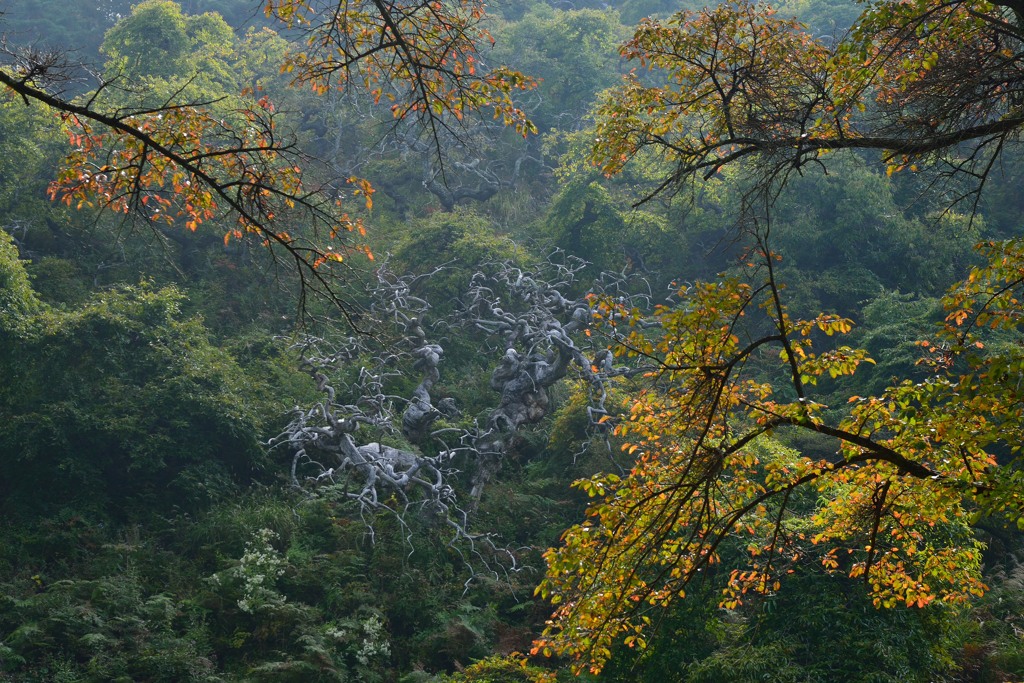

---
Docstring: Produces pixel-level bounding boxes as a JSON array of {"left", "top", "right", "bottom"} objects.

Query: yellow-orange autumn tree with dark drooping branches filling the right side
[{"left": 537, "top": 0, "right": 1024, "bottom": 672}]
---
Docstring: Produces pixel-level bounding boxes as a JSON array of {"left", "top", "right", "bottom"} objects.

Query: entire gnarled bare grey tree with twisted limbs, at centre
[{"left": 272, "top": 250, "right": 636, "bottom": 543}]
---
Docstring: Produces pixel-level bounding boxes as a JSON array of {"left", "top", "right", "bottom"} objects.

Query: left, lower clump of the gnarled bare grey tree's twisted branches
[{"left": 271, "top": 263, "right": 468, "bottom": 536}]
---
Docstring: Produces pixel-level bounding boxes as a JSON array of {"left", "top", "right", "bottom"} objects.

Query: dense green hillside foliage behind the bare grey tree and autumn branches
[{"left": 0, "top": 0, "right": 1024, "bottom": 683}]
